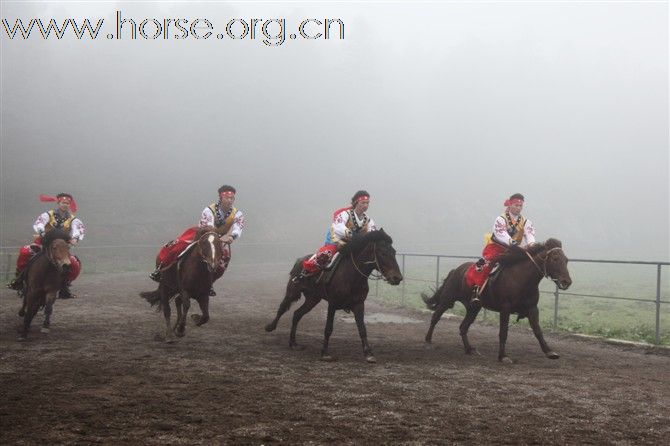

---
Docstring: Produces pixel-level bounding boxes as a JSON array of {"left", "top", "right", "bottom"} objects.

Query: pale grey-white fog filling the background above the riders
[{"left": 0, "top": 2, "right": 670, "bottom": 264}]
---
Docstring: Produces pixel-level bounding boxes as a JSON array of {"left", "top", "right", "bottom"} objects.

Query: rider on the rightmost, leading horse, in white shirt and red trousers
[{"left": 465, "top": 194, "right": 535, "bottom": 305}]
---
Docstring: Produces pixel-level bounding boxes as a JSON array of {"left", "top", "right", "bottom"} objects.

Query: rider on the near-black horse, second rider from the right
[{"left": 293, "top": 190, "right": 377, "bottom": 282}]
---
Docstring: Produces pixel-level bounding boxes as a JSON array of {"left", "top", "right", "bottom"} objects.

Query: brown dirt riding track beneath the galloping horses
[{"left": 0, "top": 265, "right": 670, "bottom": 445}]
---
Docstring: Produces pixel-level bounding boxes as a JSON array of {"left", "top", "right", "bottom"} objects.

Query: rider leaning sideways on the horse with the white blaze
[{"left": 149, "top": 184, "right": 244, "bottom": 296}]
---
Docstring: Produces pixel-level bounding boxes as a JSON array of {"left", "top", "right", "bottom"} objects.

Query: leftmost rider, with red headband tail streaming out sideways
[{"left": 7, "top": 193, "right": 86, "bottom": 299}]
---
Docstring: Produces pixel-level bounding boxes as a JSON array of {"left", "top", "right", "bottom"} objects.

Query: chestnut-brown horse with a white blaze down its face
[{"left": 140, "top": 226, "right": 223, "bottom": 343}]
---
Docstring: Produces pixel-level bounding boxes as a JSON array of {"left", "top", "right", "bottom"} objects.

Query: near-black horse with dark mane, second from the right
[{"left": 265, "top": 229, "right": 402, "bottom": 362}]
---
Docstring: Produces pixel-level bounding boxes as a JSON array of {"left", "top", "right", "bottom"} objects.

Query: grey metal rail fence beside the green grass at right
[{"left": 375, "top": 253, "right": 670, "bottom": 345}]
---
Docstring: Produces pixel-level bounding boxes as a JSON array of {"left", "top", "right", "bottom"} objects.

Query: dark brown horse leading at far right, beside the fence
[{"left": 422, "top": 238, "right": 572, "bottom": 363}]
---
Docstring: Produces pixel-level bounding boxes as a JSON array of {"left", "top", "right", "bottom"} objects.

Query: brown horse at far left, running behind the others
[{"left": 19, "top": 229, "right": 70, "bottom": 341}]
